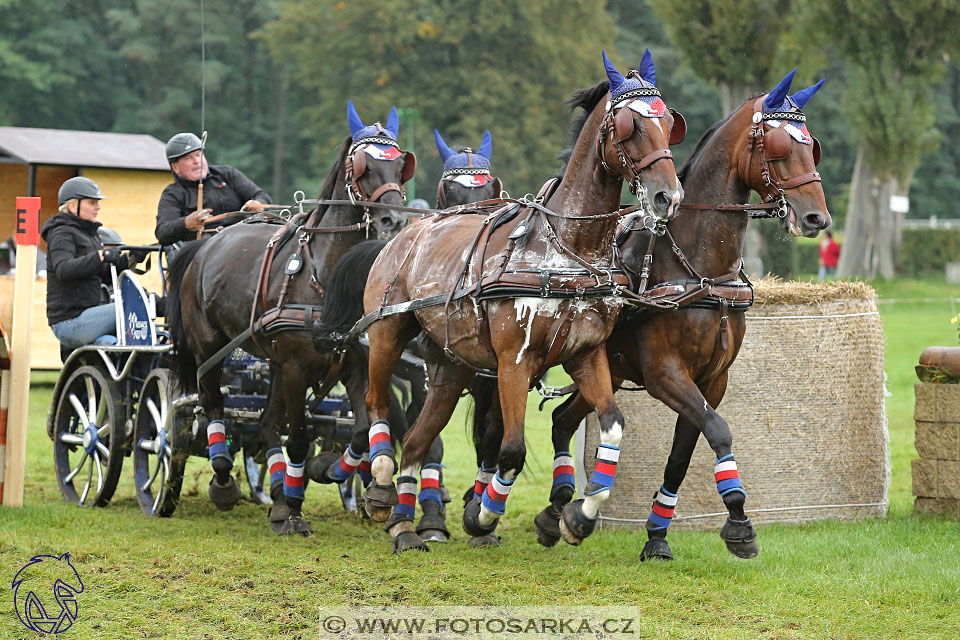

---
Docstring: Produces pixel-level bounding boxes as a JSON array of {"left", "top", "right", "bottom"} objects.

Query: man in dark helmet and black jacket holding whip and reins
[{"left": 154, "top": 133, "right": 271, "bottom": 245}]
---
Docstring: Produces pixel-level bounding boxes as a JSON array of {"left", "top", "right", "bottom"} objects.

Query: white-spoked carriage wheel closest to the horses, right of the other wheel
[{"left": 133, "top": 369, "right": 189, "bottom": 517}]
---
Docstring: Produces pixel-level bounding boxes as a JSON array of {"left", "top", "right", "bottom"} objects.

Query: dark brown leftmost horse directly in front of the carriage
[{"left": 168, "top": 101, "right": 416, "bottom": 535}]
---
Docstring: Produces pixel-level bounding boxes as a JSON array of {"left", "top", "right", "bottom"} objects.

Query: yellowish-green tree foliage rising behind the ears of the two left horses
[{"left": 263, "top": 0, "right": 614, "bottom": 195}]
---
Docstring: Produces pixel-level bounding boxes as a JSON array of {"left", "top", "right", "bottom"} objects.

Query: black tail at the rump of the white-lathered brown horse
[{"left": 313, "top": 240, "right": 387, "bottom": 351}]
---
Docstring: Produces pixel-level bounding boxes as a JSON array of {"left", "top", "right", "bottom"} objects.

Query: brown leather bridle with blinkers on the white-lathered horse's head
[{"left": 597, "top": 80, "right": 687, "bottom": 204}]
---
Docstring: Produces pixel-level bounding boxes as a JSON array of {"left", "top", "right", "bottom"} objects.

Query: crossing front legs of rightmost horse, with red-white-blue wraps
[{"left": 641, "top": 368, "right": 760, "bottom": 559}]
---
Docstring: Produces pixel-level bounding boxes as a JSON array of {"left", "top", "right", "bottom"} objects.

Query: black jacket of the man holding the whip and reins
[{"left": 154, "top": 165, "right": 271, "bottom": 245}]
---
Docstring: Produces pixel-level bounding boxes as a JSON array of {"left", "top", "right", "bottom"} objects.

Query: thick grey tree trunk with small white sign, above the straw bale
[{"left": 837, "top": 143, "right": 899, "bottom": 278}]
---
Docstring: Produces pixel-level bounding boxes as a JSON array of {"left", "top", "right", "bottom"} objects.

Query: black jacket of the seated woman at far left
[{"left": 40, "top": 213, "right": 128, "bottom": 325}]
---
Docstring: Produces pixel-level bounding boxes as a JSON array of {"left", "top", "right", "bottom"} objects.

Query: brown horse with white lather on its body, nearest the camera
[{"left": 364, "top": 50, "right": 684, "bottom": 552}]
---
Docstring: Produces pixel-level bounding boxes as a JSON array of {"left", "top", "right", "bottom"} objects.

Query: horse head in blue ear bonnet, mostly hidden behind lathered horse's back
[{"left": 433, "top": 129, "right": 503, "bottom": 208}]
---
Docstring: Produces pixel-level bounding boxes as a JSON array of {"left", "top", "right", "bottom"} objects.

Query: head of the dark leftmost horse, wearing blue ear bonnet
[{"left": 345, "top": 100, "right": 417, "bottom": 240}]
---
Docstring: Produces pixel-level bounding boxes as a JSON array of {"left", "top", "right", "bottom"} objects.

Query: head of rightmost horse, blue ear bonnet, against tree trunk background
[{"left": 743, "top": 69, "right": 832, "bottom": 237}]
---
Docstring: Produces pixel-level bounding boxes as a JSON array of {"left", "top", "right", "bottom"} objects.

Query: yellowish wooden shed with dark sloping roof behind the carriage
[{"left": 0, "top": 127, "right": 172, "bottom": 369}]
